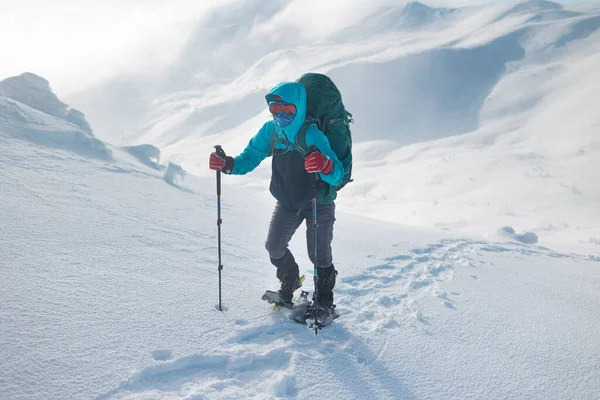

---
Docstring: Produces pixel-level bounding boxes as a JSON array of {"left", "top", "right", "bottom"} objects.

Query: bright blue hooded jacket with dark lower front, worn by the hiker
[{"left": 231, "top": 82, "right": 344, "bottom": 209}]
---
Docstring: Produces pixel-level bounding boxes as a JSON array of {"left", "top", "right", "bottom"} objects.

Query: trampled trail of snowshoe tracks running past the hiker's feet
[{"left": 97, "top": 239, "right": 600, "bottom": 400}]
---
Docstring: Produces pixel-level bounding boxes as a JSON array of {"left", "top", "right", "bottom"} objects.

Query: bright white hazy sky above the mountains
[{"left": 0, "top": 0, "right": 596, "bottom": 96}]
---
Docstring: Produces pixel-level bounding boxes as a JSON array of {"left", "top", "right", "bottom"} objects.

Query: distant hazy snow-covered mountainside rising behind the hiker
[{"left": 67, "top": 0, "right": 600, "bottom": 251}]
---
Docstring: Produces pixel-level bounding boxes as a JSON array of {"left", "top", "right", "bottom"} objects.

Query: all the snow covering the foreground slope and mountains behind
[{"left": 0, "top": 0, "right": 600, "bottom": 400}]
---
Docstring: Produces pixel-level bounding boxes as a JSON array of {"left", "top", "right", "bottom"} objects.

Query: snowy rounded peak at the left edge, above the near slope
[{"left": 0, "top": 72, "right": 92, "bottom": 135}]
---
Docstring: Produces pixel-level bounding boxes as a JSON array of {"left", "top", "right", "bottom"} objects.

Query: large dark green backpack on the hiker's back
[{"left": 296, "top": 73, "right": 354, "bottom": 191}]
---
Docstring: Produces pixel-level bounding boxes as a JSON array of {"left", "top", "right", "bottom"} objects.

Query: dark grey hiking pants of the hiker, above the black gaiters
[{"left": 265, "top": 203, "right": 335, "bottom": 267}]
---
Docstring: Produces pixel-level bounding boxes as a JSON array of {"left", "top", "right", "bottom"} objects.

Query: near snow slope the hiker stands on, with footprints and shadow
[{"left": 0, "top": 73, "right": 600, "bottom": 400}]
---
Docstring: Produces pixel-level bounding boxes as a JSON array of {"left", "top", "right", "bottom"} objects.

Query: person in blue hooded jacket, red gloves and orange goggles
[{"left": 209, "top": 82, "right": 344, "bottom": 319}]
